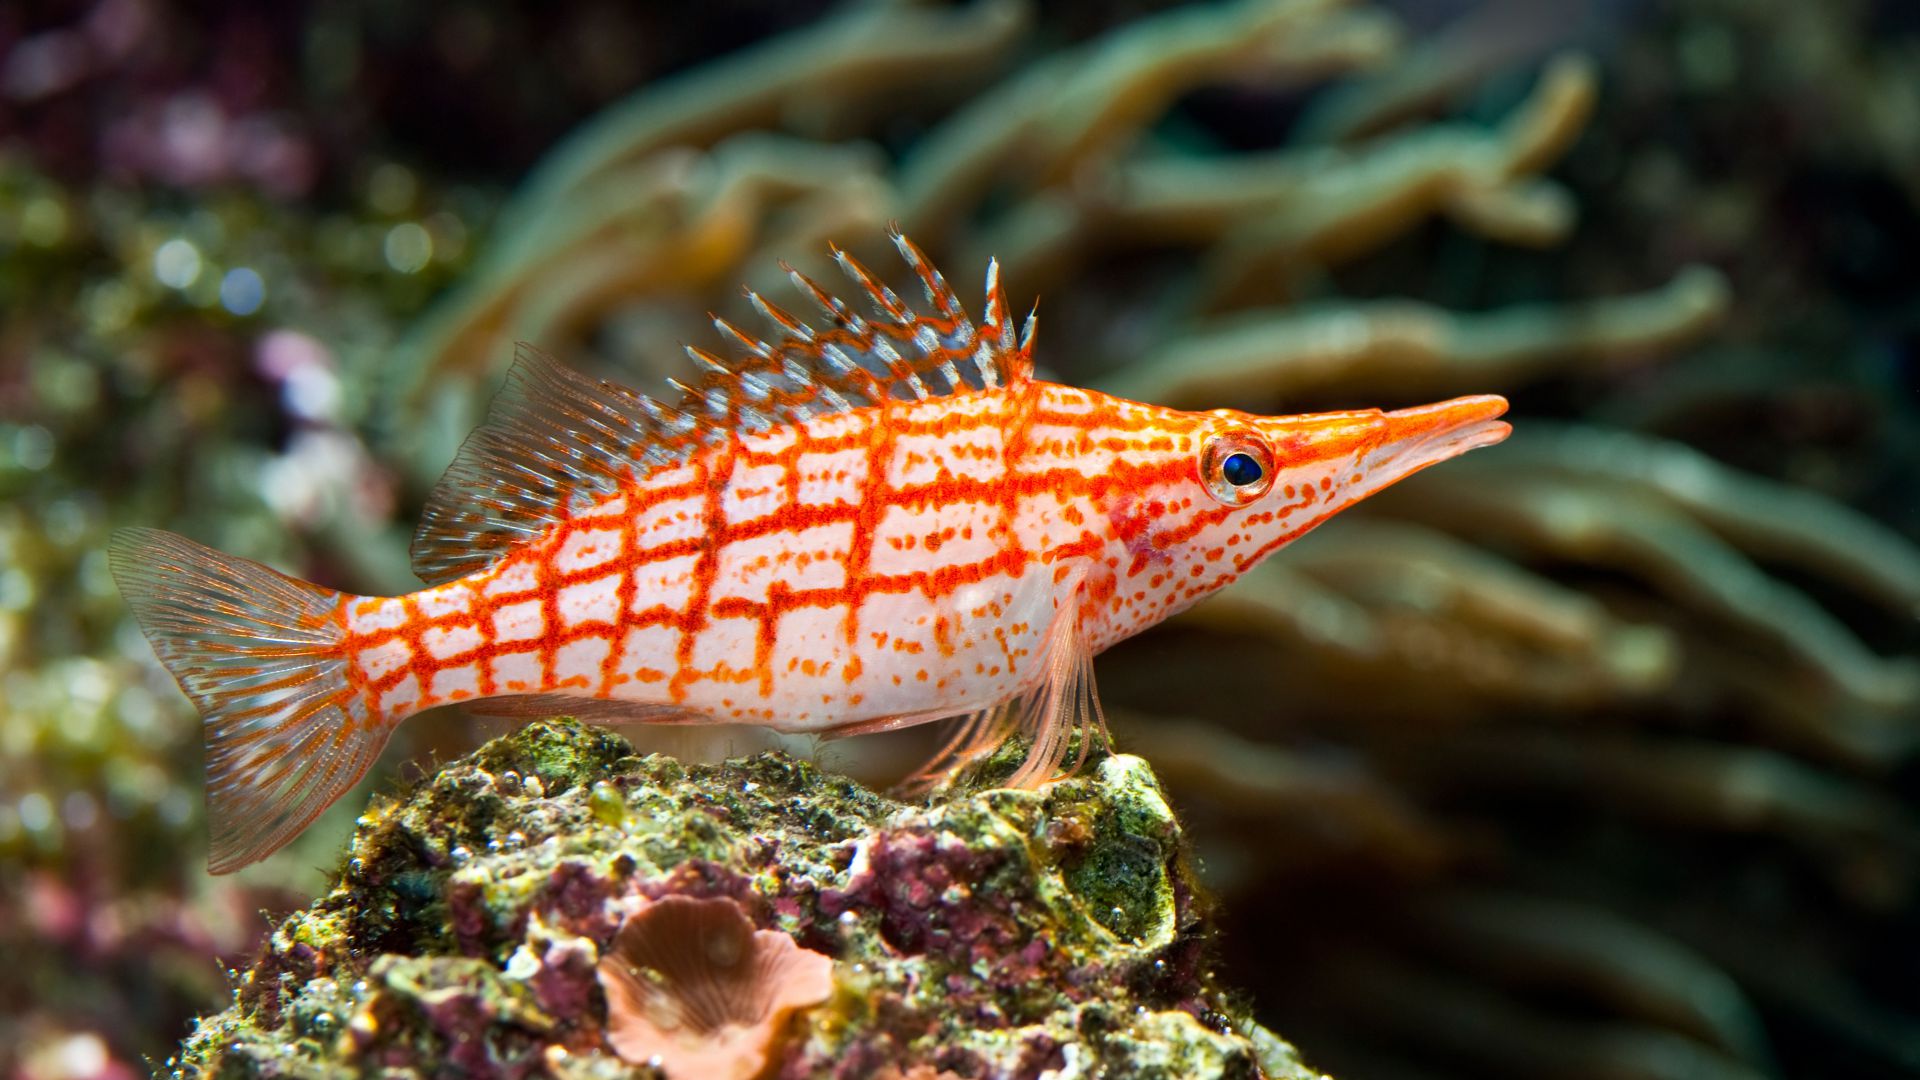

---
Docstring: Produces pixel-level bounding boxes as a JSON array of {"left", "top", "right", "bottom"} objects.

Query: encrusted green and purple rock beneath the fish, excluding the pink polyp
[{"left": 177, "top": 721, "right": 1308, "bottom": 1080}]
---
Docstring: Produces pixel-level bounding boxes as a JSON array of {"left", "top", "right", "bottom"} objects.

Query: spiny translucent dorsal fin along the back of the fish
[{"left": 413, "top": 233, "right": 1033, "bottom": 584}]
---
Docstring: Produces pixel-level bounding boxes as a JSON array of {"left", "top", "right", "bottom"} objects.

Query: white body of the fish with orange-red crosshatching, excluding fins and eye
[{"left": 340, "top": 382, "right": 1512, "bottom": 730}]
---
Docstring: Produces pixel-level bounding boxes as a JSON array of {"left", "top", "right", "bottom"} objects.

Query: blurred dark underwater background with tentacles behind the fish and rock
[{"left": 0, "top": 0, "right": 1920, "bottom": 1080}]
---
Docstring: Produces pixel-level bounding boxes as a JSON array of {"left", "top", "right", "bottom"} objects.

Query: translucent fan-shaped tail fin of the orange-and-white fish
[{"left": 108, "top": 528, "right": 390, "bottom": 874}]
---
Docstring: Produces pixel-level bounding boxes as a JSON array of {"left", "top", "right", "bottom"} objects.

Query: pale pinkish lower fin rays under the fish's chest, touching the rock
[{"left": 899, "top": 582, "right": 1112, "bottom": 794}]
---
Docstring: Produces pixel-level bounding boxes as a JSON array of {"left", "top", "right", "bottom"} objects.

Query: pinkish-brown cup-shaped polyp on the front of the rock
[{"left": 597, "top": 896, "right": 833, "bottom": 1080}]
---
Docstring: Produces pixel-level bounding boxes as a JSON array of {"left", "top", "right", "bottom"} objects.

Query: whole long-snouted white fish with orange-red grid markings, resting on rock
[{"left": 111, "top": 236, "right": 1507, "bottom": 872}]
